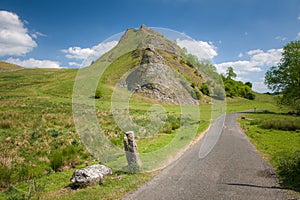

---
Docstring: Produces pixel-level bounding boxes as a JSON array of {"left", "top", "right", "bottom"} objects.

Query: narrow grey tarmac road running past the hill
[{"left": 124, "top": 114, "right": 289, "bottom": 200}]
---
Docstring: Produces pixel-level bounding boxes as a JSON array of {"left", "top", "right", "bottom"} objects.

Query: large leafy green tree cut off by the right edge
[{"left": 265, "top": 40, "right": 300, "bottom": 113}]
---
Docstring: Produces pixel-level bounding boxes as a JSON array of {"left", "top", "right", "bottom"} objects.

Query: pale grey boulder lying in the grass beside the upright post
[{"left": 70, "top": 164, "right": 112, "bottom": 187}]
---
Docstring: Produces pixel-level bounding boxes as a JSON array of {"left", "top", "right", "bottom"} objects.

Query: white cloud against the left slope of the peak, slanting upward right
[{"left": 61, "top": 40, "right": 118, "bottom": 66}]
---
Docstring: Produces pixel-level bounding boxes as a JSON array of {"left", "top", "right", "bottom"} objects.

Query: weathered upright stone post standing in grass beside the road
[{"left": 123, "top": 131, "right": 142, "bottom": 167}]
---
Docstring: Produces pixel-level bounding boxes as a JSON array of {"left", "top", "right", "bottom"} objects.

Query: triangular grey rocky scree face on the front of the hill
[{"left": 119, "top": 45, "right": 197, "bottom": 104}]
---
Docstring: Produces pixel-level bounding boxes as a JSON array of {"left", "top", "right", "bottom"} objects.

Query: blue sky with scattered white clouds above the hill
[{"left": 0, "top": 0, "right": 300, "bottom": 92}]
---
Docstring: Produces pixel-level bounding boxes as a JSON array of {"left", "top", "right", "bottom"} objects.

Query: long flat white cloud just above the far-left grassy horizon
[{"left": 6, "top": 58, "right": 61, "bottom": 68}]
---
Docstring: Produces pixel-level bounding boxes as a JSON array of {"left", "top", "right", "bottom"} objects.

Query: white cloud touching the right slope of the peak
[{"left": 176, "top": 39, "right": 218, "bottom": 60}]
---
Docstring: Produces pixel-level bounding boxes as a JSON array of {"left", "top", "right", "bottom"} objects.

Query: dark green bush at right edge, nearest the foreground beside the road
[{"left": 277, "top": 151, "right": 300, "bottom": 189}]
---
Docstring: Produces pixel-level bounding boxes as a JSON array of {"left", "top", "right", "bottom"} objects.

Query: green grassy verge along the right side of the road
[{"left": 239, "top": 113, "right": 300, "bottom": 192}]
